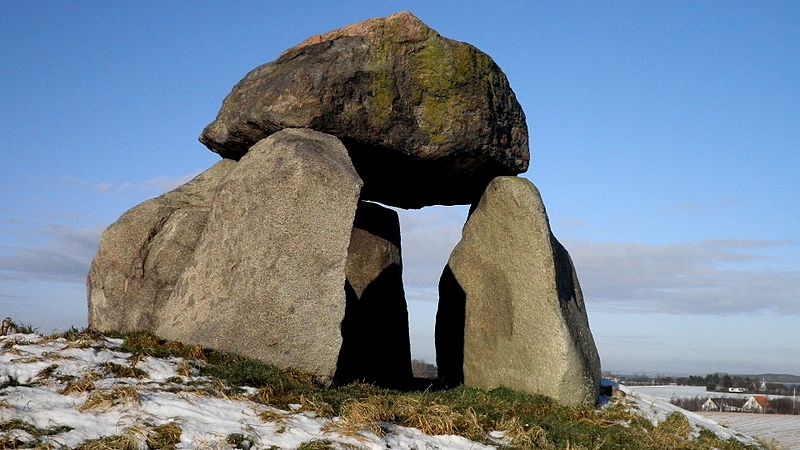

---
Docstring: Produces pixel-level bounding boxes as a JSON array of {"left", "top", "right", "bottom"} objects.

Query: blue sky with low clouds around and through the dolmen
[{"left": 0, "top": 1, "right": 800, "bottom": 374}]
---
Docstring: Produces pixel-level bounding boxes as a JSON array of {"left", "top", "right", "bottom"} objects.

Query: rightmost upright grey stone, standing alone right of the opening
[{"left": 437, "top": 177, "right": 600, "bottom": 404}]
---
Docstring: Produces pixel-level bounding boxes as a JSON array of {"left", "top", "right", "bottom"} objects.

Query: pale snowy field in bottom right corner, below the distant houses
[{"left": 699, "top": 412, "right": 800, "bottom": 450}]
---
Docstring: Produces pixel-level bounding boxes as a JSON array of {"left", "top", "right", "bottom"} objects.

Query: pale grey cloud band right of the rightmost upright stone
[{"left": 565, "top": 240, "right": 800, "bottom": 315}]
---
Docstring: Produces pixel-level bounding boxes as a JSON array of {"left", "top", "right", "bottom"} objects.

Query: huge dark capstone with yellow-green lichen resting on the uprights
[{"left": 200, "top": 13, "right": 529, "bottom": 208}]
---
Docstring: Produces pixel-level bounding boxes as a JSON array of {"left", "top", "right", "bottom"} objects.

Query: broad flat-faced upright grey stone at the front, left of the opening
[{"left": 156, "top": 129, "right": 362, "bottom": 377}]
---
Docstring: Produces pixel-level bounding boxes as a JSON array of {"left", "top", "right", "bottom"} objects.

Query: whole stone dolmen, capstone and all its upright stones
[{"left": 87, "top": 13, "right": 600, "bottom": 404}]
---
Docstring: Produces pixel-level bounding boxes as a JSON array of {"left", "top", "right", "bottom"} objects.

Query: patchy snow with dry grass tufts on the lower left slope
[{"left": 0, "top": 334, "right": 493, "bottom": 450}]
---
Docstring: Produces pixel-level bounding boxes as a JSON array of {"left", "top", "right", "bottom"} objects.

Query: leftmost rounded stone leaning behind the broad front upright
[{"left": 86, "top": 160, "right": 236, "bottom": 331}]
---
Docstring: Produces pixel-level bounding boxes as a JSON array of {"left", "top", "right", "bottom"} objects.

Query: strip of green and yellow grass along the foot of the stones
[{"left": 90, "top": 331, "right": 757, "bottom": 450}]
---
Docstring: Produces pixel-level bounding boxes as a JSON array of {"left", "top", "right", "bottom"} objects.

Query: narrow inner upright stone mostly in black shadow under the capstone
[{"left": 335, "top": 202, "right": 412, "bottom": 387}]
